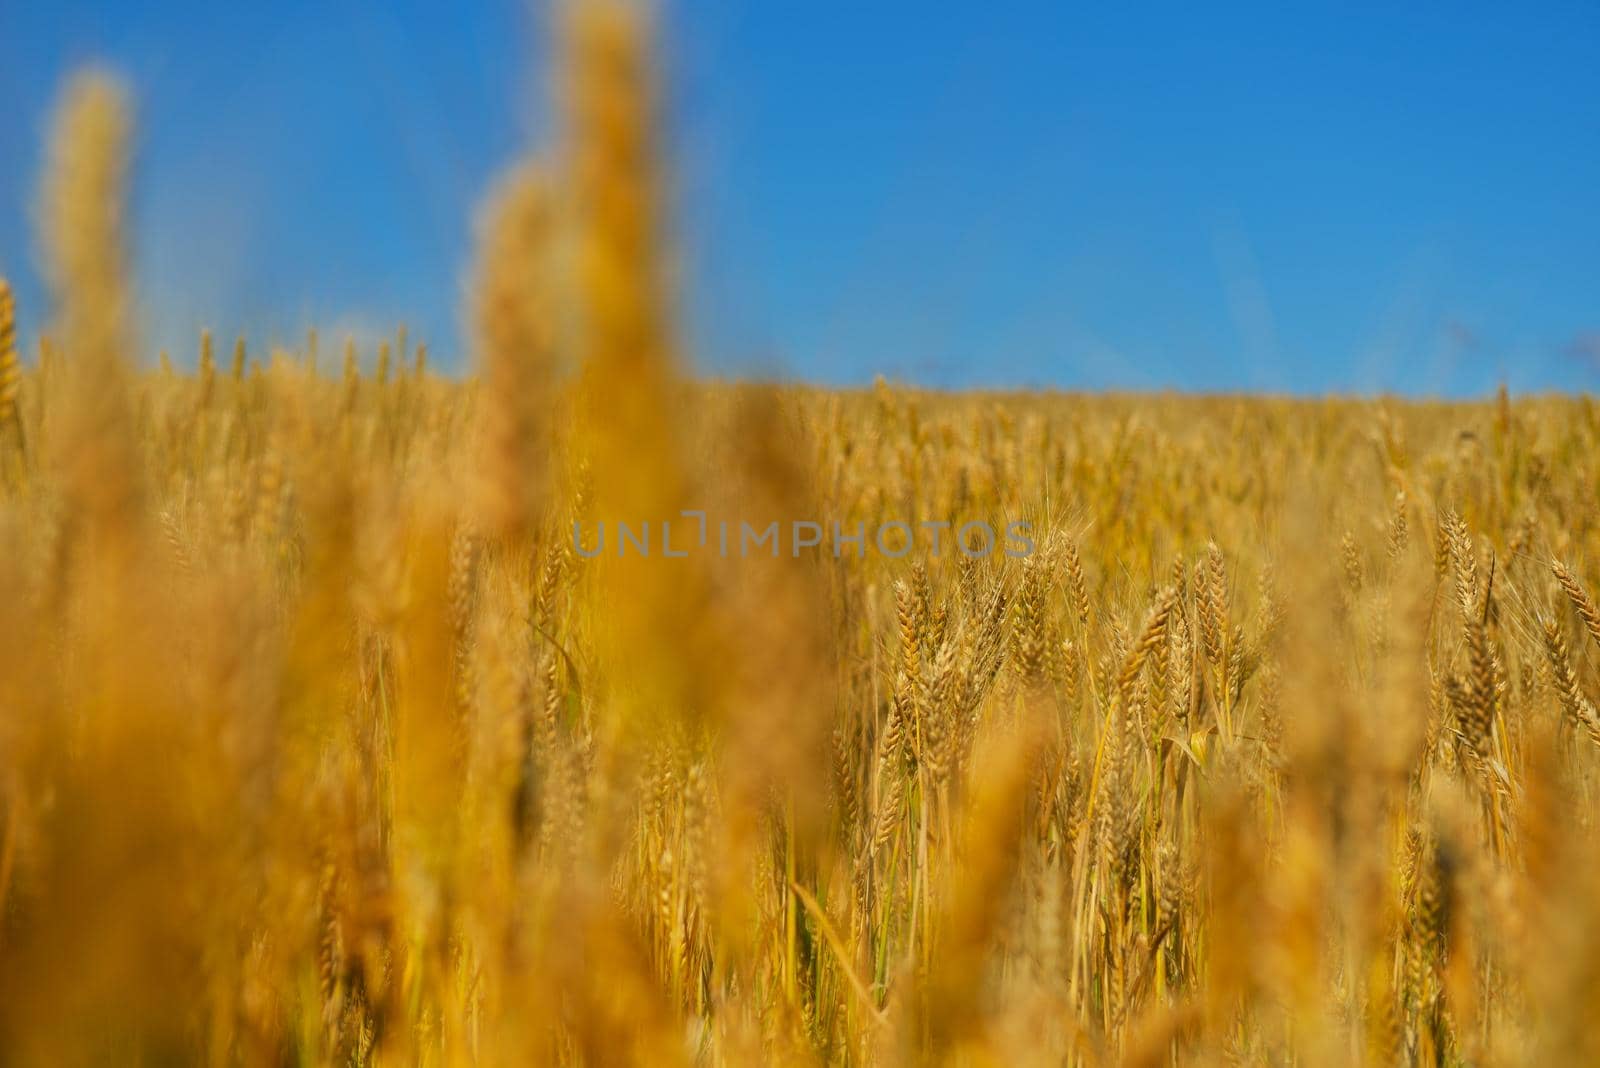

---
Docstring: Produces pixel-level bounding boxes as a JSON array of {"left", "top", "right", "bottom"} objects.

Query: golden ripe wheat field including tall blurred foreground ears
[{"left": 0, "top": 2, "right": 1600, "bottom": 1066}]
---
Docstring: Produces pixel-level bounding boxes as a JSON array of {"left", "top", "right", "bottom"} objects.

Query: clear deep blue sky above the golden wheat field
[{"left": 0, "top": 0, "right": 1600, "bottom": 395}]
